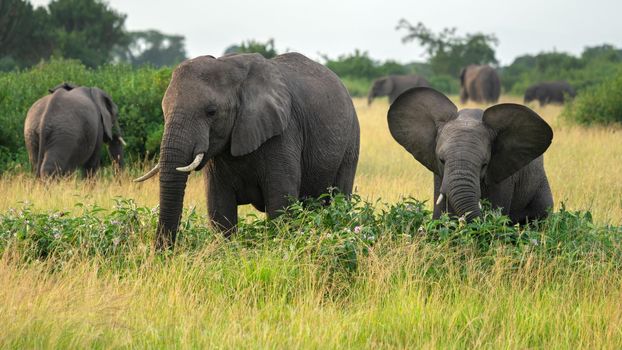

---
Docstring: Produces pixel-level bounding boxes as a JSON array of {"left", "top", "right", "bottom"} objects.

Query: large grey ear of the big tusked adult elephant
[{"left": 231, "top": 55, "right": 291, "bottom": 156}]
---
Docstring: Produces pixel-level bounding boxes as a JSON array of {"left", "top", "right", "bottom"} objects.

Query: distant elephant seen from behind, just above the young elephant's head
[{"left": 460, "top": 65, "right": 501, "bottom": 103}]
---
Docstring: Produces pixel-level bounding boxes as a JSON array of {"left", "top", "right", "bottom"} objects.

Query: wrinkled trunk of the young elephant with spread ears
[{"left": 442, "top": 162, "right": 481, "bottom": 221}]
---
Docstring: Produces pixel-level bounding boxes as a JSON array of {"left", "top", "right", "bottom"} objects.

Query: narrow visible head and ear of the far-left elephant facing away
[{"left": 90, "top": 87, "right": 125, "bottom": 167}]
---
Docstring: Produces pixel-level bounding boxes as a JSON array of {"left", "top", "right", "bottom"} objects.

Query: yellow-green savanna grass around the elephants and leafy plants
[{"left": 0, "top": 97, "right": 622, "bottom": 349}]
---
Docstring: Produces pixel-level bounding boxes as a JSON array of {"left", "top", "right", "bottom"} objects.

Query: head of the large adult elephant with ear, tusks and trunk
[{"left": 136, "top": 54, "right": 292, "bottom": 248}]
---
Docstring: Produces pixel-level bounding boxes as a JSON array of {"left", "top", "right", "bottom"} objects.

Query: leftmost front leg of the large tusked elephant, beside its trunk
[{"left": 204, "top": 169, "right": 238, "bottom": 237}]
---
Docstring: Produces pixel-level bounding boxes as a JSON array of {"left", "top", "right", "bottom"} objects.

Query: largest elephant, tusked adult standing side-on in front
[{"left": 137, "top": 53, "right": 359, "bottom": 248}]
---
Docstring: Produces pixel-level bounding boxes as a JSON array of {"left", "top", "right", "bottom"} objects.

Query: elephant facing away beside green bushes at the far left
[{"left": 24, "top": 83, "right": 123, "bottom": 177}]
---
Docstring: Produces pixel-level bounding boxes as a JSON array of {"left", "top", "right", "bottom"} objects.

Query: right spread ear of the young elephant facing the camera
[{"left": 483, "top": 103, "right": 553, "bottom": 183}]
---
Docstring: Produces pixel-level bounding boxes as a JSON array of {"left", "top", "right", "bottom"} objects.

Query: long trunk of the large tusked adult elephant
[{"left": 156, "top": 124, "right": 193, "bottom": 249}]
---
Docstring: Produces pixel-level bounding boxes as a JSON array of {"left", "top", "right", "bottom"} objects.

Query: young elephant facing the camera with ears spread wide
[{"left": 388, "top": 88, "right": 553, "bottom": 223}]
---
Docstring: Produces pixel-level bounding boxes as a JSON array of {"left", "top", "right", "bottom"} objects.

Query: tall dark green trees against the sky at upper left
[{"left": 0, "top": 0, "right": 186, "bottom": 70}]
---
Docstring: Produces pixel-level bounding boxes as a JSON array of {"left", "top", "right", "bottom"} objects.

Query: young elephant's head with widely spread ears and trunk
[{"left": 388, "top": 88, "right": 553, "bottom": 220}]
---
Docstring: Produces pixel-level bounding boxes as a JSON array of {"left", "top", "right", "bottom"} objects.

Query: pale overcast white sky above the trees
[{"left": 31, "top": 0, "right": 622, "bottom": 64}]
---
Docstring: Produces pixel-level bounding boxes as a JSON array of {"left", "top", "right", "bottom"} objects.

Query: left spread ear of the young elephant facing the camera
[{"left": 387, "top": 87, "right": 458, "bottom": 175}]
